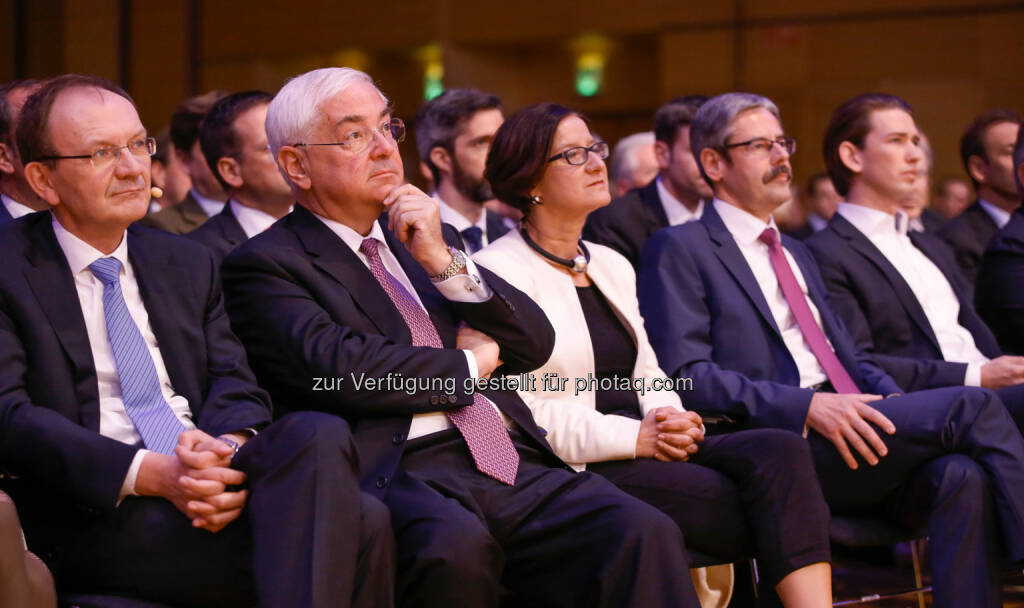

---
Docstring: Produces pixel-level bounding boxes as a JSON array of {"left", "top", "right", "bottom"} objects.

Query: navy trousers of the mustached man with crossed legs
[{"left": 808, "top": 388, "right": 1024, "bottom": 608}]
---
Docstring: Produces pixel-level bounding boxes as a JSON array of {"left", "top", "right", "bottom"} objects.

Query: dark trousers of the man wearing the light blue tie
[{"left": 53, "top": 412, "right": 394, "bottom": 608}]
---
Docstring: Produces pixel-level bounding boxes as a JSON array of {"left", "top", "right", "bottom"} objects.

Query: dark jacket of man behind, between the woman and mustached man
[{"left": 583, "top": 178, "right": 669, "bottom": 268}]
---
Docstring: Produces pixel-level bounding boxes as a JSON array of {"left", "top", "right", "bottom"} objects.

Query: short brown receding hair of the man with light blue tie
[{"left": 15, "top": 74, "right": 138, "bottom": 165}]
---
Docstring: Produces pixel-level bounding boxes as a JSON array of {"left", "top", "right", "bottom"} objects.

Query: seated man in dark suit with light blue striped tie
[{"left": 0, "top": 75, "right": 393, "bottom": 607}]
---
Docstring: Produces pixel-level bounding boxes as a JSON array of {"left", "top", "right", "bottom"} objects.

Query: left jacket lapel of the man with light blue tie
[{"left": 26, "top": 213, "right": 99, "bottom": 432}]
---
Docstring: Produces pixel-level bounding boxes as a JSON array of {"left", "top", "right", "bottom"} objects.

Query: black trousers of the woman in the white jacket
[{"left": 587, "top": 429, "right": 829, "bottom": 590}]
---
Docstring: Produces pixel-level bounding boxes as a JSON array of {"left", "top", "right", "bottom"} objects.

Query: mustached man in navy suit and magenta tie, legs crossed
[{"left": 638, "top": 93, "right": 1024, "bottom": 606}]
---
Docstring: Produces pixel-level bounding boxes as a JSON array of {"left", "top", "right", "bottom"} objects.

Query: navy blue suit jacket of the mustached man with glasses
[{"left": 637, "top": 205, "right": 902, "bottom": 433}]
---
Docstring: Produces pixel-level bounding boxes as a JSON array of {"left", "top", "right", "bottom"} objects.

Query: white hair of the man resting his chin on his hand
[{"left": 266, "top": 68, "right": 388, "bottom": 157}]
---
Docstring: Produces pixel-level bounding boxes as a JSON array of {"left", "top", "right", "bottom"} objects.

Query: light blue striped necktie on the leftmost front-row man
[{"left": 89, "top": 252, "right": 185, "bottom": 453}]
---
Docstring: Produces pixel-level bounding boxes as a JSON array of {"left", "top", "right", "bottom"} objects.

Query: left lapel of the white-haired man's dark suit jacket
[{"left": 290, "top": 205, "right": 413, "bottom": 344}]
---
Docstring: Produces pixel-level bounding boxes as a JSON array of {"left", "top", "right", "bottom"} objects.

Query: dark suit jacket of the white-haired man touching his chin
[{"left": 223, "top": 206, "right": 560, "bottom": 495}]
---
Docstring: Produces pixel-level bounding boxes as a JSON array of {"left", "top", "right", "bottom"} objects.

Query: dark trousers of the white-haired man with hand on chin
[{"left": 385, "top": 430, "right": 699, "bottom": 608}]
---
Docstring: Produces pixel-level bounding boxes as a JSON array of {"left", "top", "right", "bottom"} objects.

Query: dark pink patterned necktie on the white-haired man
[{"left": 359, "top": 238, "right": 519, "bottom": 485}]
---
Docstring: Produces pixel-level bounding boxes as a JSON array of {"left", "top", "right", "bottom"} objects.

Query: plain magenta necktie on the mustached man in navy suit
[{"left": 758, "top": 228, "right": 860, "bottom": 393}]
